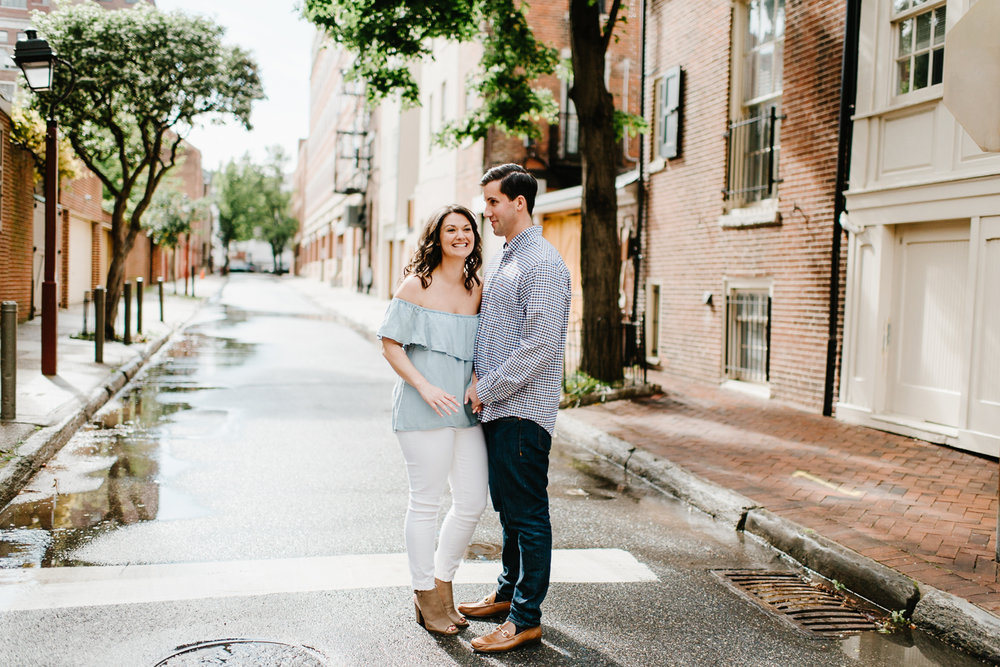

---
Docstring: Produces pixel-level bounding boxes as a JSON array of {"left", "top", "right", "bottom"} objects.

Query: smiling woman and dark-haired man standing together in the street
[{"left": 377, "top": 164, "right": 571, "bottom": 652}]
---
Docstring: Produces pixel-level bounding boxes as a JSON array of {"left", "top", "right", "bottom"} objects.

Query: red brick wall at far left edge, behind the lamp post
[{"left": 0, "top": 112, "right": 40, "bottom": 321}]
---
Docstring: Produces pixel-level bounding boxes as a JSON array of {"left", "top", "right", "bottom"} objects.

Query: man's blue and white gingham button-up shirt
[{"left": 474, "top": 226, "right": 572, "bottom": 434}]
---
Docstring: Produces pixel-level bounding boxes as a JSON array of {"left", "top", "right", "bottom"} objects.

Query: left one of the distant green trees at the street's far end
[{"left": 212, "top": 154, "right": 266, "bottom": 274}]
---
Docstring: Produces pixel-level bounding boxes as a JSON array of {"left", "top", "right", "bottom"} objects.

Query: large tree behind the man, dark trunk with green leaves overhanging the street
[{"left": 305, "top": 0, "right": 642, "bottom": 382}]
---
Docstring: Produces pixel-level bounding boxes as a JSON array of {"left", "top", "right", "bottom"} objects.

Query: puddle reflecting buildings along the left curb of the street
[{"left": 0, "top": 330, "right": 254, "bottom": 569}]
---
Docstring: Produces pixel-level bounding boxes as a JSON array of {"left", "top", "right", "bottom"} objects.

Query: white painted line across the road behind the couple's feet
[{"left": 0, "top": 549, "right": 658, "bottom": 612}]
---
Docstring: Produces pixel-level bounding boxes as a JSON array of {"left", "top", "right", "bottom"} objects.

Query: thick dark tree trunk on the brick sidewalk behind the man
[{"left": 570, "top": 0, "right": 623, "bottom": 382}]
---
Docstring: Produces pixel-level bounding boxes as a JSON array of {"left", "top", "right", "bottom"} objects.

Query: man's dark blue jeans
[{"left": 483, "top": 417, "right": 552, "bottom": 627}]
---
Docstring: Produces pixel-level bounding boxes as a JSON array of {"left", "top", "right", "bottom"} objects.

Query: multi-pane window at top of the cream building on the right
[{"left": 893, "top": 0, "right": 946, "bottom": 95}]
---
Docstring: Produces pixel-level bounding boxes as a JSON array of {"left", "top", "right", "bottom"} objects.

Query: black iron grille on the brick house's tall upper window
[{"left": 723, "top": 106, "right": 785, "bottom": 208}]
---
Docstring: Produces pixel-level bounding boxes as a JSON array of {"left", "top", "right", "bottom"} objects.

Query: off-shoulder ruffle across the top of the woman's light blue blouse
[{"left": 375, "top": 299, "right": 479, "bottom": 361}]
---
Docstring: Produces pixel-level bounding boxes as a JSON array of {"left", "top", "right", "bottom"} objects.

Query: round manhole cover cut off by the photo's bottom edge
[{"left": 156, "top": 639, "right": 326, "bottom": 667}]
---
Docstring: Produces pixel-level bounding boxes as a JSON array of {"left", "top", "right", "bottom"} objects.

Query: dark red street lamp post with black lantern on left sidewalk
[{"left": 14, "top": 30, "right": 76, "bottom": 375}]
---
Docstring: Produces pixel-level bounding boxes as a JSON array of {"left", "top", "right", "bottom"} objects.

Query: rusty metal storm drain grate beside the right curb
[{"left": 714, "top": 570, "right": 878, "bottom": 637}]
